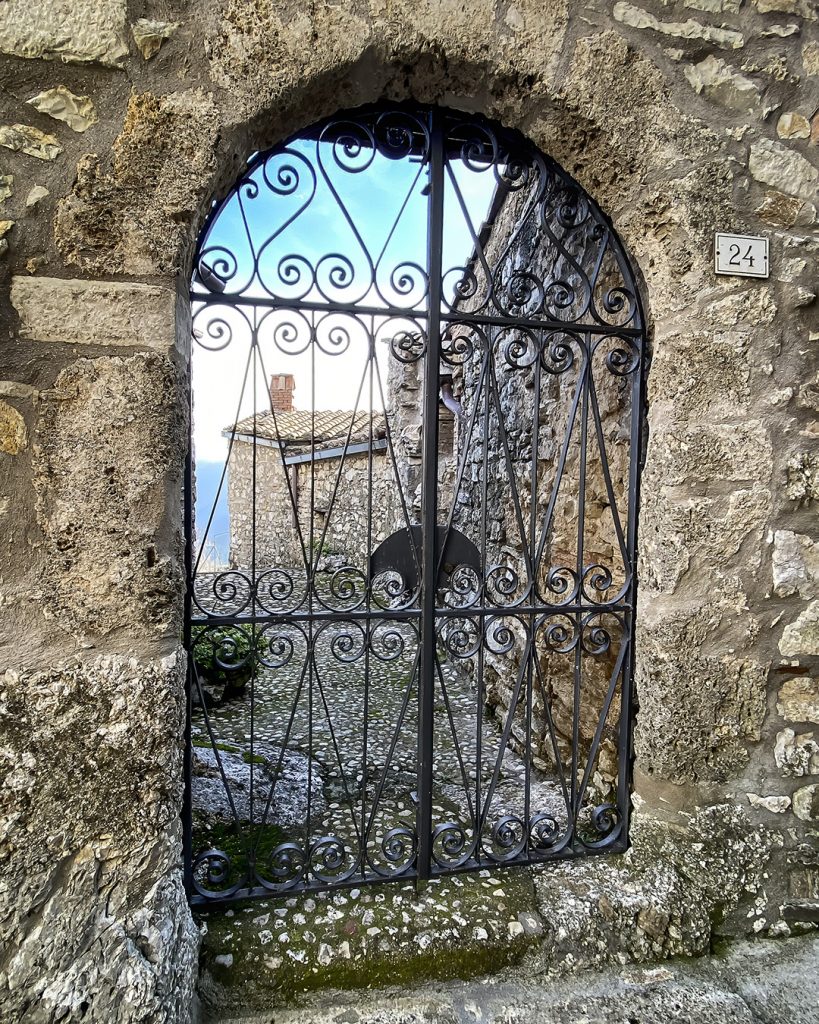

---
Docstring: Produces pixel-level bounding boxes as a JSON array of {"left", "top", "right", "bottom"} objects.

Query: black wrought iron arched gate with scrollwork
[{"left": 185, "top": 105, "right": 645, "bottom": 902}]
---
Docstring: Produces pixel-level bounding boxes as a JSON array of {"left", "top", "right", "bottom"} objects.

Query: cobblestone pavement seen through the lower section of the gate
[{"left": 192, "top": 622, "right": 566, "bottom": 879}]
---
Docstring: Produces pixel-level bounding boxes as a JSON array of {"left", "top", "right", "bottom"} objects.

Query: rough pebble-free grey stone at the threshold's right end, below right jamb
[{"left": 532, "top": 806, "right": 771, "bottom": 975}]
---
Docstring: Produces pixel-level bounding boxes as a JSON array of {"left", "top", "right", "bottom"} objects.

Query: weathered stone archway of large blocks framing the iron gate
[{"left": 3, "top": 0, "right": 819, "bottom": 1022}]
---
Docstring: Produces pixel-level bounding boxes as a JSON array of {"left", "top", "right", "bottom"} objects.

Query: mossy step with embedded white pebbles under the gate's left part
[{"left": 200, "top": 869, "right": 544, "bottom": 1012}]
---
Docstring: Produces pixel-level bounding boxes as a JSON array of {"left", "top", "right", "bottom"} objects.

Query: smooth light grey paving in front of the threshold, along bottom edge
[{"left": 203, "top": 933, "right": 819, "bottom": 1024}]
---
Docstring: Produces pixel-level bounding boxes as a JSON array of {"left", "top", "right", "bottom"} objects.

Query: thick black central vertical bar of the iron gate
[{"left": 417, "top": 109, "right": 443, "bottom": 879}]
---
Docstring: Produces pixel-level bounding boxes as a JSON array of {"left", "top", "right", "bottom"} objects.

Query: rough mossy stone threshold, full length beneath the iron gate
[{"left": 200, "top": 805, "right": 782, "bottom": 1024}]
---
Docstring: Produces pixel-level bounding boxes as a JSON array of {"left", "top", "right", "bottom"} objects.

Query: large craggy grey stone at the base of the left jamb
[{"left": 0, "top": 657, "right": 198, "bottom": 1024}]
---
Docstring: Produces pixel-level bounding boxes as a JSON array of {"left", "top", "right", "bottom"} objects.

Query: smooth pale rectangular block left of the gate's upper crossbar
[{"left": 11, "top": 276, "right": 176, "bottom": 352}]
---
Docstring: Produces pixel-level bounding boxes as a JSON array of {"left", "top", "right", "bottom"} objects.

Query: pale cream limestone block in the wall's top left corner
[{"left": 0, "top": 0, "right": 128, "bottom": 68}]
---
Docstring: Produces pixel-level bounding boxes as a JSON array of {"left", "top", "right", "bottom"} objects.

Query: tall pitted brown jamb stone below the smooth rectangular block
[{"left": 34, "top": 353, "right": 185, "bottom": 644}]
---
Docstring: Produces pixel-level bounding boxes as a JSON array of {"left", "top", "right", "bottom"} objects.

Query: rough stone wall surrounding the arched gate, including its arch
[{"left": 0, "top": 0, "right": 819, "bottom": 1024}]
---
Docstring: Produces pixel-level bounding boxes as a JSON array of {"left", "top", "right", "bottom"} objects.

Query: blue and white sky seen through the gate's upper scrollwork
[{"left": 192, "top": 140, "right": 494, "bottom": 555}]
